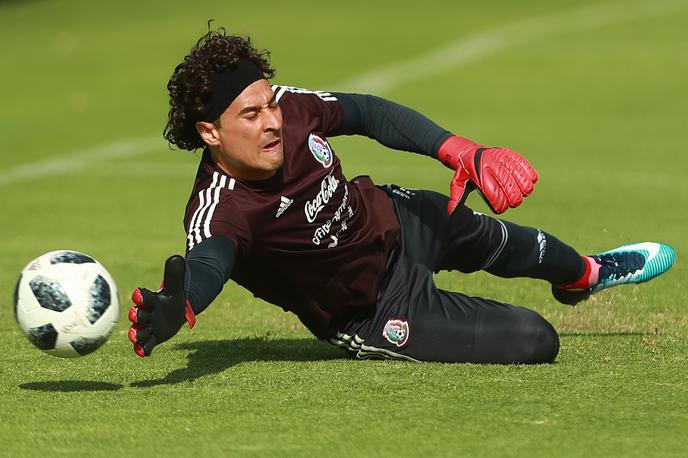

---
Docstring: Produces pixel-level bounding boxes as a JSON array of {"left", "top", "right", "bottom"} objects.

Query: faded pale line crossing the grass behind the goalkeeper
[{"left": 0, "top": 1, "right": 688, "bottom": 188}]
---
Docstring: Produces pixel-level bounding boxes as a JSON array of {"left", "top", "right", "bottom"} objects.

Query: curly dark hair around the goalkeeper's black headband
[{"left": 163, "top": 23, "right": 275, "bottom": 151}]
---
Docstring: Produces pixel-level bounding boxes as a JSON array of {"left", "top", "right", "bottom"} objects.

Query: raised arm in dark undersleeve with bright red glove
[{"left": 331, "top": 93, "right": 538, "bottom": 213}]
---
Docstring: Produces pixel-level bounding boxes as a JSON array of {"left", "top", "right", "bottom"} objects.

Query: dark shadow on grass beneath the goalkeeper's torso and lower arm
[{"left": 130, "top": 337, "right": 346, "bottom": 388}]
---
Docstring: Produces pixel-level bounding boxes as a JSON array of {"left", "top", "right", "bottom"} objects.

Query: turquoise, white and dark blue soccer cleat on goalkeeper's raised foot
[{"left": 552, "top": 242, "right": 676, "bottom": 305}]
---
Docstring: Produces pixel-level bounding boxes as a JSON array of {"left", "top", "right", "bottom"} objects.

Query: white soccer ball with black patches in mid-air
[{"left": 14, "top": 250, "right": 119, "bottom": 358}]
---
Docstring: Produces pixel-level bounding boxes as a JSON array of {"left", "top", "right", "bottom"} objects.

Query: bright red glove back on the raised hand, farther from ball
[{"left": 438, "top": 136, "right": 538, "bottom": 214}]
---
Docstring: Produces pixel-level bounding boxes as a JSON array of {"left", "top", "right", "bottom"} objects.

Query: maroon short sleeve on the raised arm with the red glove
[{"left": 272, "top": 85, "right": 344, "bottom": 136}]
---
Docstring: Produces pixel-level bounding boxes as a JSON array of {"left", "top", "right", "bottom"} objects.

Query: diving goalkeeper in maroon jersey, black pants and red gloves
[{"left": 129, "top": 29, "right": 674, "bottom": 363}]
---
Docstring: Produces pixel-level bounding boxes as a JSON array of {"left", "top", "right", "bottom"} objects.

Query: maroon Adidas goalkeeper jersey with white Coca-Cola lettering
[{"left": 184, "top": 86, "right": 399, "bottom": 339}]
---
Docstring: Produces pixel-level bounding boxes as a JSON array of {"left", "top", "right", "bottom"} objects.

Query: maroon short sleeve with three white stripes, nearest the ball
[{"left": 184, "top": 172, "right": 251, "bottom": 255}]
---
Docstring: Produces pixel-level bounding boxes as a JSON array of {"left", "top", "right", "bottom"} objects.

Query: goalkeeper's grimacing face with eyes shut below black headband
[{"left": 201, "top": 79, "right": 284, "bottom": 180}]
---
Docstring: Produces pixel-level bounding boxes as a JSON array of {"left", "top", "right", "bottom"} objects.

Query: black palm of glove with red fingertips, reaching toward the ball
[{"left": 129, "top": 255, "right": 196, "bottom": 356}]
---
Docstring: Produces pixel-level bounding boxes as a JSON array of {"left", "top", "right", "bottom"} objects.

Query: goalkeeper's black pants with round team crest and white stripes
[{"left": 331, "top": 185, "right": 584, "bottom": 363}]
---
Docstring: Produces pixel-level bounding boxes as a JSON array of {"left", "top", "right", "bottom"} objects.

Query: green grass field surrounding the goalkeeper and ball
[{"left": 0, "top": 0, "right": 688, "bottom": 457}]
